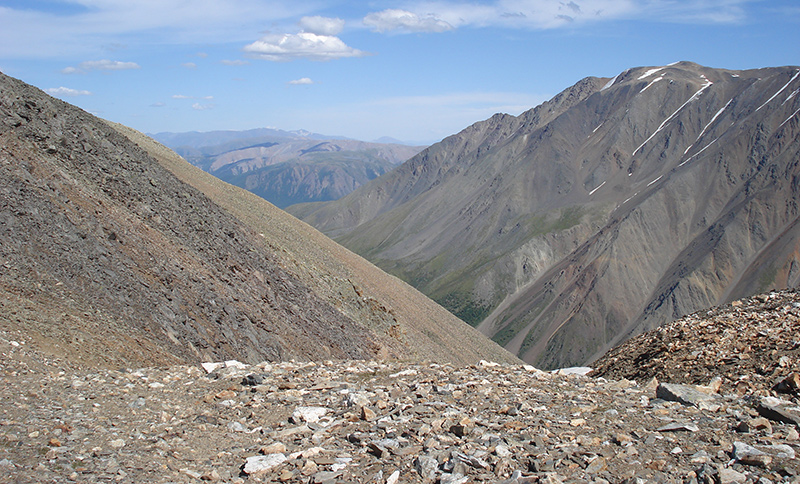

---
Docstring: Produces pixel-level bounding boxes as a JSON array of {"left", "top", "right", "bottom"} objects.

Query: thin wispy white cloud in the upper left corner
[{"left": 0, "top": 0, "right": 318, "bottom": 58}]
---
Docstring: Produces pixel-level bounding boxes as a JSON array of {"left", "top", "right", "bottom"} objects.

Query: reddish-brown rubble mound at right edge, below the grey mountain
[{"left": 593, "top": 290, "right": 800, "bottom": 395}]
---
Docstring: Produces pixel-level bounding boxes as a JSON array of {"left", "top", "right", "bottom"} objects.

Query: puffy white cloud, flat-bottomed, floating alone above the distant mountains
[{"left": 244, "top": 32, "right": 366, "bottom": 61}]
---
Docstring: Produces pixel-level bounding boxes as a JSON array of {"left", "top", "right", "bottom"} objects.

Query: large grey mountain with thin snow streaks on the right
[{"left": 289, "top": 62, "right": 800, "bottom": 368}]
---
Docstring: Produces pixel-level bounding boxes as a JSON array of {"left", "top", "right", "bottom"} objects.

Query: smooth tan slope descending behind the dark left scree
[{"left": 113, "top": 124, "right": 518, "bottom": 363}]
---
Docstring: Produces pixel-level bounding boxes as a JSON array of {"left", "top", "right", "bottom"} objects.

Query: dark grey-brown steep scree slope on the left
[{"left": 0, "top": 71, "right": 510, "bottom": 366}]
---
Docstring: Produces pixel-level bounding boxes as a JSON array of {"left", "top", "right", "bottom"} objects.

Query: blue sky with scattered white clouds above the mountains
[{"left": 0, "top": 0, "right": 800, "bottom": 143}]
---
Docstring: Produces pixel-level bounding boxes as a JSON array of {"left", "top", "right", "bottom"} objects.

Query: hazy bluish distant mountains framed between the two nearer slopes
[{"left": 152, "top": 128, "right": 423, "bottom": 207}]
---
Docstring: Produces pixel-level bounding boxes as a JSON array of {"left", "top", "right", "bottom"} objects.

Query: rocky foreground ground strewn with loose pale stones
[{"left": 0, "top": 303, "right": 800, "bottom": 484}]
